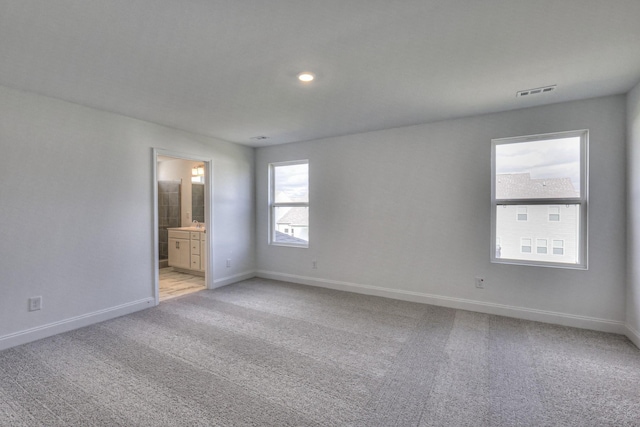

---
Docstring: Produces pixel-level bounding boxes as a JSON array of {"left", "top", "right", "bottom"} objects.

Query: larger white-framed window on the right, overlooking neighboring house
[{"left": 491, "top": 130, "right": 588, "bottom": 269}]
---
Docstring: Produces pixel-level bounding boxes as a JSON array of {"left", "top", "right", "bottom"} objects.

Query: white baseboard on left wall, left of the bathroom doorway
[{"left": 0, "top": 298, "right": 155, "bottom": 350}]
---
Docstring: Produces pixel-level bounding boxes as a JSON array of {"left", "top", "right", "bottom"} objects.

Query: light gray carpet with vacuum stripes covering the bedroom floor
[{"left": 0, "top": 279, "right": 640, "bottom": 427}]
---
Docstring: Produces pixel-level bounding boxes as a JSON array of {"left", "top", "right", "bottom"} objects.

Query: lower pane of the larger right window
[{"left": 496, "top": 204, "right": 580, "bottom": 264}]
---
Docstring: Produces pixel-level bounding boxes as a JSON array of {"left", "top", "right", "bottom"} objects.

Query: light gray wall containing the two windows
[{"left": 256, "top": 96, "right": 626, "bottom": 332}]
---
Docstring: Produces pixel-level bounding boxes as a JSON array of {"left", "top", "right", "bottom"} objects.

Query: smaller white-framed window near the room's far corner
[{"left": 269, "top": 160, "right": 309, "bottom": 248}]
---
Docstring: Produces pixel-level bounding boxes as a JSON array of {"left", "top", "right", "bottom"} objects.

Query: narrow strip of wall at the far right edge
[{"left": 626, "top": 83, "right": 640, "bottom": 347}]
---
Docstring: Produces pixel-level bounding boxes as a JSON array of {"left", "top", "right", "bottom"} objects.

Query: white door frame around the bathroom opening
[{"left": 151, "top": 147, "right": 213, "bottom": 305}]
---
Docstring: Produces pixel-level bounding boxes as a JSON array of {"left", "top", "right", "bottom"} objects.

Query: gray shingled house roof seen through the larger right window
[{"left": 496, "top": 173, "right": 580, "bottom": 199}]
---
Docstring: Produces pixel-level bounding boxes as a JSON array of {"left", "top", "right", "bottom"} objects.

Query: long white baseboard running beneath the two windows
[{"left": 256, "top": 270, "right": 624, "bottom": 336}]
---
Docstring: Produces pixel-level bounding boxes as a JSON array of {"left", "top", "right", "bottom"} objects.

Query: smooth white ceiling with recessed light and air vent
[{"left": 0, "top": 0, "right": 640, "bottom": 147}]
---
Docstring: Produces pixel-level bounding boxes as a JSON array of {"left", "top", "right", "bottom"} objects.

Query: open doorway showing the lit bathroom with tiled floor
[{"left": 153, "top": 149, "right": 213, "bottom": 305}]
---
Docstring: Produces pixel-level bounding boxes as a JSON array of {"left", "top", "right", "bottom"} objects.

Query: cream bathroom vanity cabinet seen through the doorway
[{"left": 168, "top": 227, "right": 207, "bottom": 274}]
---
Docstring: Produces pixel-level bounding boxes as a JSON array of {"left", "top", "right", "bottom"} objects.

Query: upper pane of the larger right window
[{"left": 495, "top": 137, "right": 580, "bottom": 199}]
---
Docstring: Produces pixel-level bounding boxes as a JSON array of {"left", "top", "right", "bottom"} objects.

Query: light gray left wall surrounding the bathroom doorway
[{"left": 0, "top": 87, "right": 255, "bottom": 348}]
